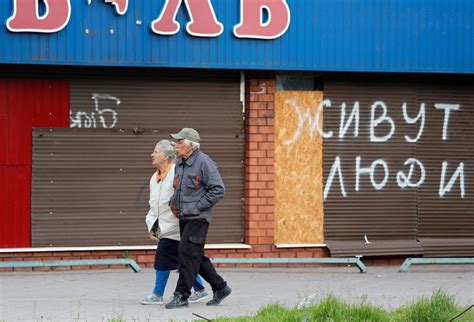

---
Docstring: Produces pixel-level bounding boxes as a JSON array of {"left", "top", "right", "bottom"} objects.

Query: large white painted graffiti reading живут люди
[{"left": 283, "top": 99, "right": 465, "bottom": 199}]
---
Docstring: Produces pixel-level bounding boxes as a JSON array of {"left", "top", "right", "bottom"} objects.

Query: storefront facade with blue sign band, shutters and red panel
[{"left": 0, "top": 0, "right": 474, "bottom": 266}]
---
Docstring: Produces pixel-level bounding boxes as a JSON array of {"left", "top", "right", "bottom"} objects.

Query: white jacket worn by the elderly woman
[{"left": 146, "top": 164, "right": 180, "bottom": 240}]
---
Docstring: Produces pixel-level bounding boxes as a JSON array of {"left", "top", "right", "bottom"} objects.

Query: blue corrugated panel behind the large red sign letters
[{"left": 0, "top": 0, "right": 474, "bottom": 74}]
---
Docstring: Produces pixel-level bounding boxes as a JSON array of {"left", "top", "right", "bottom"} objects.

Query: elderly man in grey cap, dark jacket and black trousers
[{"left": 165, "top": 128, "right": 231, "bottom": 309}]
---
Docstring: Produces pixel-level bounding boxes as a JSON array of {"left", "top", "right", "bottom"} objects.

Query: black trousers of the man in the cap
[{"left": 176, "top": 219, "right": 227, "bottom": 299}]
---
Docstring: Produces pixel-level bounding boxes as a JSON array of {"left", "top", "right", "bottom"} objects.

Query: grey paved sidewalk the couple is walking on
[{"left": 0, "top": 265, "right": 474, "bottom": 321}]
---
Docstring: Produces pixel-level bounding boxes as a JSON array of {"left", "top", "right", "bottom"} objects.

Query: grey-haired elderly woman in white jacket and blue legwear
[{"left": 140, "top": 140, "right": 208, "bottom": 305}]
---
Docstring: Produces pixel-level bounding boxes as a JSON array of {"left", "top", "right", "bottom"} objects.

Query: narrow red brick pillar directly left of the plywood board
[{"left": 245, "top": 75, "right": 275, "bottom": 252}]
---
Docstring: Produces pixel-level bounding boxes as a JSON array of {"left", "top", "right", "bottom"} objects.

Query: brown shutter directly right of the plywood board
[{"left": 323, "top": 80, "right": 422, "bottom": 256}]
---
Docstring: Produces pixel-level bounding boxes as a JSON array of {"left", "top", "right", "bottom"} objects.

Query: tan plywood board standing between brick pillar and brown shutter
[{"left": 275, "top": 91, "right": 324, "bottom": 244}]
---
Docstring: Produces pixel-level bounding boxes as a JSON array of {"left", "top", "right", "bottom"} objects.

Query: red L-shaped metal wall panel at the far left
[{"left": 0, "top": 79, "right": 69, "bottom": 247}]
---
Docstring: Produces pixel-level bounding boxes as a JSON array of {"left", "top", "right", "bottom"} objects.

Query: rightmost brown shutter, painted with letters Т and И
[{"left": 417, "top": 80, "right": 474, "bottom": 256}]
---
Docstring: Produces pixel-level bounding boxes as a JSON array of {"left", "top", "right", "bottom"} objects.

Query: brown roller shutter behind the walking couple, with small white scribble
[{"left": 32, "top": 74, "right": 245, "bottom": 246}]
